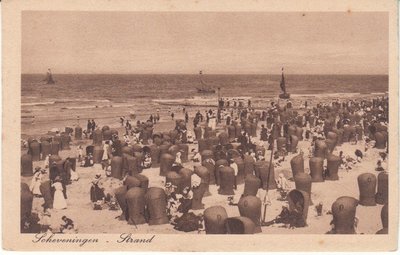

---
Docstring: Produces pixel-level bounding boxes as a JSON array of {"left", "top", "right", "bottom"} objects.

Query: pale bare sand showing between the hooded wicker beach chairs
[{"left": 21, "top": 95, "right": 385, "bottom": 234}]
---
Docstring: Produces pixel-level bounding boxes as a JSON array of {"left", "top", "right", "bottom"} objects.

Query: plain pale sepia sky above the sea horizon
[{"left": 21, "top": 11, "right": 389, "bottom": 74}]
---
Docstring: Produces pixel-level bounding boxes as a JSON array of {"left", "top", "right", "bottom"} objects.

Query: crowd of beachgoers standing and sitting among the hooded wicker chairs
[{"left": 20, "top": 94, "right": 389, "bottom": 234}]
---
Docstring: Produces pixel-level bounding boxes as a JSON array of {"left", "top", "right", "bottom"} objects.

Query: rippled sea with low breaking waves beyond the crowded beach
[{"left": 21, "top": 74, "right": 388, "bottom": 137}]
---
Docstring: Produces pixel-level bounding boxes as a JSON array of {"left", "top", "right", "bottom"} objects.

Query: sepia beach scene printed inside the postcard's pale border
[{"left": 3, "top": 0, "right": 398, "bottom": 250}]
